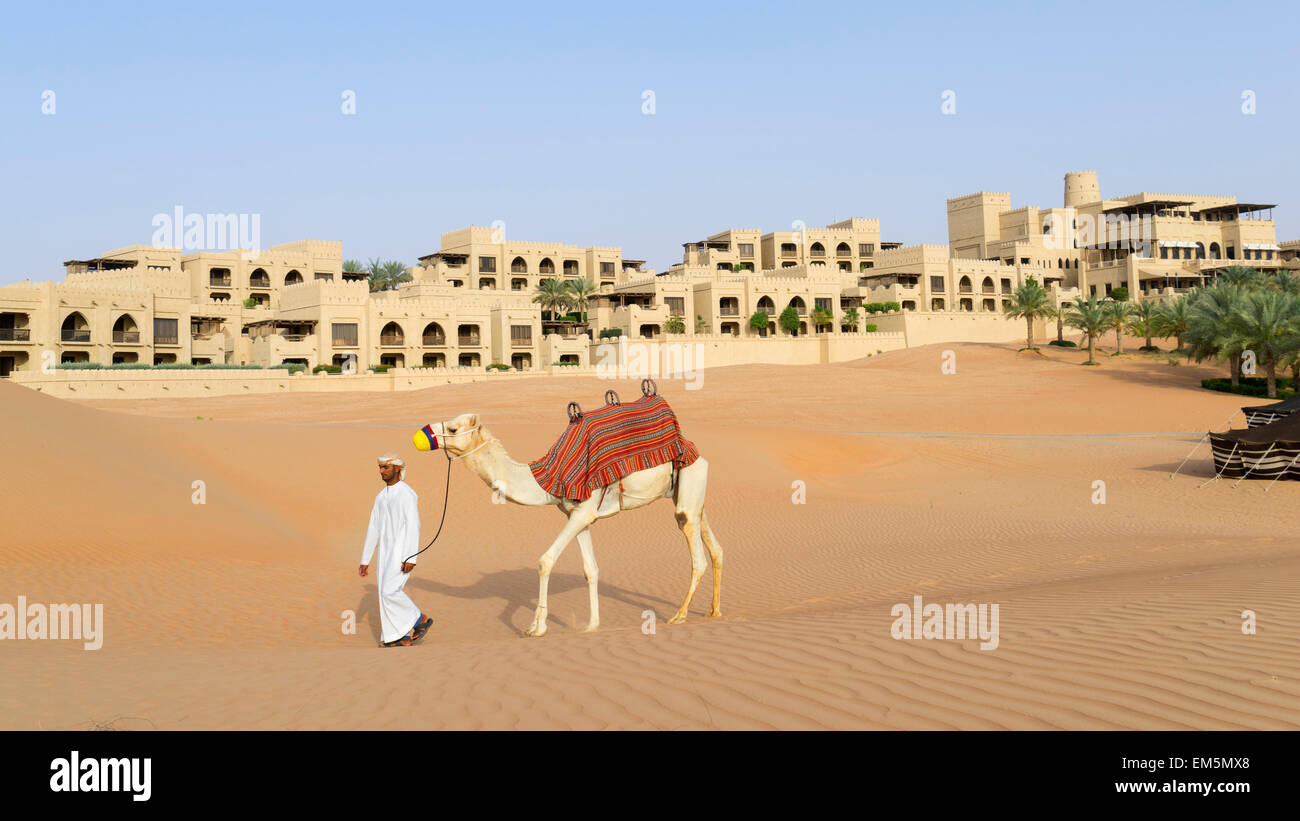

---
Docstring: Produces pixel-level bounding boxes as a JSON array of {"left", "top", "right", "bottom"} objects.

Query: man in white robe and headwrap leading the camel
[{"left": 359, "top": 453, "right": 433, "bottom": 647}]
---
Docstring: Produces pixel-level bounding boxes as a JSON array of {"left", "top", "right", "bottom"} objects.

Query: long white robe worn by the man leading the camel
[{"left": 361, "top": 481, "right": 420, "bottom": 642}]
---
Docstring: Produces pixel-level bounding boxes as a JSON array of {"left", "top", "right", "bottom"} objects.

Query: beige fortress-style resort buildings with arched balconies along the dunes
[{"left": 0, "top": 171, "right": 1300, "bottom": 375}]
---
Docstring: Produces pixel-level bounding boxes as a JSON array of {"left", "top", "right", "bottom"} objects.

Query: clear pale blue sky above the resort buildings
[{"left": 0, "top": 1, "right": 1300, "bottom": 283}]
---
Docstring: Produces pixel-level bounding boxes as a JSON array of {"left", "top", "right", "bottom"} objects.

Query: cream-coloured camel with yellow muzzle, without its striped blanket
[{"left": 415, "top": 413, "right": 723, "bottom": 638}]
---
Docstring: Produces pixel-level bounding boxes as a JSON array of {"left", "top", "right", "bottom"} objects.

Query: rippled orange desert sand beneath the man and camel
[{"left": 0, "top": 344, "right": 1300, "bottom": 729}]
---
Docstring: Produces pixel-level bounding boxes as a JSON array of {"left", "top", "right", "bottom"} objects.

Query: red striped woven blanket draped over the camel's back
[{"left": 528, "top": 395, "right": 699, "bottom": 501}]
